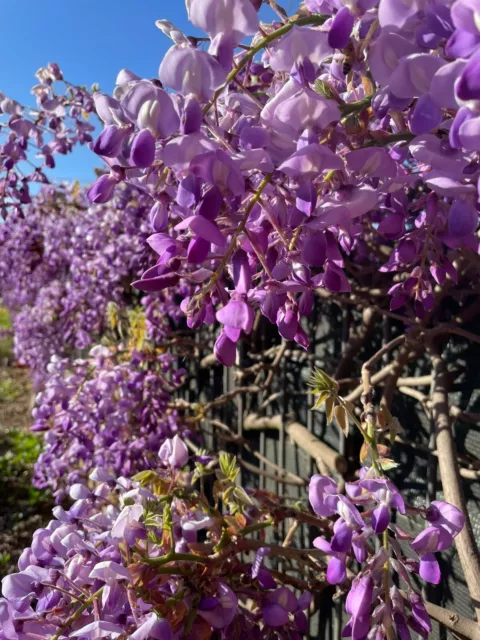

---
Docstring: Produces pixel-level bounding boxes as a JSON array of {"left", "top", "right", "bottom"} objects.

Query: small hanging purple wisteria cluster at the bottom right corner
[{"left": 309, "top": 468, "right": 465, "bottom": 640}]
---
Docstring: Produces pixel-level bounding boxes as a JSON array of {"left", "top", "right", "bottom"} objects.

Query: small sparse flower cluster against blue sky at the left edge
[{"left": 0, "top": 63, "right": 95, "bottom": 219}]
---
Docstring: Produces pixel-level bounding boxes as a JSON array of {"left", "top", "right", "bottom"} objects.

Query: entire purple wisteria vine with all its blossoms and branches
[{"left": 0, "top": 0, "right": 480, "bottom": 640}]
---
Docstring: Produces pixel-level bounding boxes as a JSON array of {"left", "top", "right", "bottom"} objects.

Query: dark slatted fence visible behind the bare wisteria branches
[{"left": 177, "top": 302, "right": 480, "bottom": 640}]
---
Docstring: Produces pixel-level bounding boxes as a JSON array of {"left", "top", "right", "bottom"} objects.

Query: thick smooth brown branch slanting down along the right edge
[{"left": 429, "top": 344, "right": 480, "bottom": 620}]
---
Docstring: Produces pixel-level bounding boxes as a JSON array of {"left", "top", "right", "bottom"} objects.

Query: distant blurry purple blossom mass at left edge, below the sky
[{"left": 0, "top": 185, "right": 156, "bottom": 385}]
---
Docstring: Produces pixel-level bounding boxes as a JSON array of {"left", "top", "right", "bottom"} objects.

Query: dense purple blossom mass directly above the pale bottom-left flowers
[{"left": 32, "top": 345, "right": 188, "bottom": 502}]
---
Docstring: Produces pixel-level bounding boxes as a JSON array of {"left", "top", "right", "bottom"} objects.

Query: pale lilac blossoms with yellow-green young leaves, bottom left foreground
[{"left": 0, "top": 444, "right": 312, "bottom": 640}]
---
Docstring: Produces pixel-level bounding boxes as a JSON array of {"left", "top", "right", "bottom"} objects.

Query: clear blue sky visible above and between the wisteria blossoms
[{"left": 0, "top": 0, "right": 298, "bottom": 188}]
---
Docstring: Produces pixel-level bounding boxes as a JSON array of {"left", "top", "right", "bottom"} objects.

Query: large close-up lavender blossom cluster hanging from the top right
[{"left": 89, "top": 0, "right": 480, "bottom": 365}]
